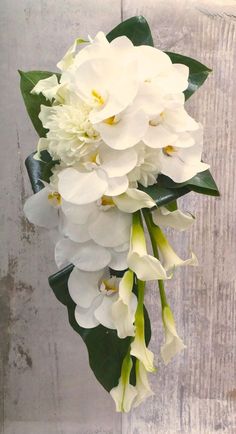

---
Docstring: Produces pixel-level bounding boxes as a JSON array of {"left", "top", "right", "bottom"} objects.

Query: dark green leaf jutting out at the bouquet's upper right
[{"left": 166, "top": 51, "right": 212, "bottom": 100}]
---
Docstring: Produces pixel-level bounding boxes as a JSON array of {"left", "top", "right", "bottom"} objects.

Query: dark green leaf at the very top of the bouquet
[{"left": 107, "top": 16, "right": 153, "bottom": 46}]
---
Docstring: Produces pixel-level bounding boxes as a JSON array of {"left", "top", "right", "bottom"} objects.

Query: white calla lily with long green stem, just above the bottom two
[{"left": 130, "top": 280, "right": 156, "bottom": 372}]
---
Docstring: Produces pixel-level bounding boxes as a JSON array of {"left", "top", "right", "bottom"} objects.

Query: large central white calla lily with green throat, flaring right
[{"left": 127, "top": 212, "right": 167, "bottom": 281}]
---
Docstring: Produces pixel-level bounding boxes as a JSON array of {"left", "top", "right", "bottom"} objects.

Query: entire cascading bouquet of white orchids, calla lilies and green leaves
[{"left": 20, "top": 17, "right": 219, "bottom": 412}]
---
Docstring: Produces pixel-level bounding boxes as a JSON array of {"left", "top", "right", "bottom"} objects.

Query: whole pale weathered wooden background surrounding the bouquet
[{"left": 0, "top": 0, "right": 236, "bottom": 434}]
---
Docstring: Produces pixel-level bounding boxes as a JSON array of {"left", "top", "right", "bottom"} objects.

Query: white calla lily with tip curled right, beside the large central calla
[{"left": 152, "top": 226, "right": 198, "bottom": 275}]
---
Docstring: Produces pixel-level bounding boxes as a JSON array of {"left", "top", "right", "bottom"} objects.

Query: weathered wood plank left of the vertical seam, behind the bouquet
[{"left": 0, "top": 0, "right": 121, "bottom": 434}]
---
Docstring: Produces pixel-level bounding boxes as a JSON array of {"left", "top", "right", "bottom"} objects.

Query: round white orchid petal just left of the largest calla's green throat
[{"left": 89, "top": 208, "right": 131, "bottom": 247}]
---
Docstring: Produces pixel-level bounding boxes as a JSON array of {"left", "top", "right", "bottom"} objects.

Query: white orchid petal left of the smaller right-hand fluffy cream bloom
[{"left": 99, "top": 147, "right": 137, "bottom": 177}]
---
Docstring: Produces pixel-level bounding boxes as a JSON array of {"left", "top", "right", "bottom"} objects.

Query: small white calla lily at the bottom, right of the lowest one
[{"left": 133, "top": 360, "right": 154, "bottom": 407}]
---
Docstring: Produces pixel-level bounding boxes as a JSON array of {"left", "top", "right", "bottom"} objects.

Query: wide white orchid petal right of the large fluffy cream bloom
[{"left": 96, "top": 110, "right": 148, "bottom": 150}]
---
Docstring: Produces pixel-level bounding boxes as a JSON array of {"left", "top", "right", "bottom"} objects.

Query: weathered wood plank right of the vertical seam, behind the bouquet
[{"left": 123, "top": 0, "right": 236, "bottom": 434}]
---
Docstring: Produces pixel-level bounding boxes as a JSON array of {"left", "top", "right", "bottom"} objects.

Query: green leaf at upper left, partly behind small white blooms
[{"left": 19, "top": 71, "right": 60, "bottom": 137}]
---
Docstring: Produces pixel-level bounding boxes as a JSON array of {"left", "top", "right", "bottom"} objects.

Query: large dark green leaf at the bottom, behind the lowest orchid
[{"left": 49, "top": 266, "right": 151, "bottom": 391}]
